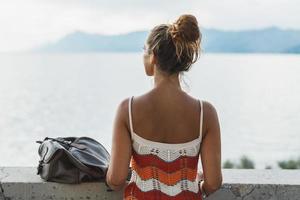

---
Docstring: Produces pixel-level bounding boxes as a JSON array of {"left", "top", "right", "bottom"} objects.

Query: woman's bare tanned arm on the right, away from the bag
[{"left": 201, "top": 102, "right": 223, "bottom": 195}]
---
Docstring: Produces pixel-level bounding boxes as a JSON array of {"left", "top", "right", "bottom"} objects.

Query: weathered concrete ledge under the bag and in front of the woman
[{"left": 0, "top": 167, "right": 300, "bottom": 200}]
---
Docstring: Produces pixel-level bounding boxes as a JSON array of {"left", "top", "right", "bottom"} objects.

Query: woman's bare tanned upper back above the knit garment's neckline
[{"left": 132, "top": 88, "right": 201, "bottom": 143}]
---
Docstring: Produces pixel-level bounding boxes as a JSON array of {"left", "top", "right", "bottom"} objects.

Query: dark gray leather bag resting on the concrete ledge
[{"left": 37, "top": 137, "right": 110, "bottom": 183}]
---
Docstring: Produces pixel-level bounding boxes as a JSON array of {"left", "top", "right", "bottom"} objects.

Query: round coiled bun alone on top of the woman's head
[{"left": 169, "top": 14, "right": 200, "bottom": 42}]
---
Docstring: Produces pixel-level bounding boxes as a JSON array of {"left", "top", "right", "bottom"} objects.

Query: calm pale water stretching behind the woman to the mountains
[{"left": 0, "top": 53, "right": 300, "bottom": 168}]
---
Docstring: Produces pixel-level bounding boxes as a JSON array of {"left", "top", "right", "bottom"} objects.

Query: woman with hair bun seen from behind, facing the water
[{"left": 106, "top": 15, "right": 222, "bottom": 200}]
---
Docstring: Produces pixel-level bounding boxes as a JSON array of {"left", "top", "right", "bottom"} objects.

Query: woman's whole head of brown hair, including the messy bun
[{"left": 147, "top": 14, "right": 202, "bottom": 74}]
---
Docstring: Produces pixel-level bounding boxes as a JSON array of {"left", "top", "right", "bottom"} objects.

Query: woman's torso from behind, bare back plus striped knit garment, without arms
[{"left": 124, "top": 90, "right": 203, "bottom": 199}]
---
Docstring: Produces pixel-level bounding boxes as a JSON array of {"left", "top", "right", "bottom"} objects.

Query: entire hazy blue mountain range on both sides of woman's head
[{"left": 33, "top": 27, "right": 300, "bottom": 53}]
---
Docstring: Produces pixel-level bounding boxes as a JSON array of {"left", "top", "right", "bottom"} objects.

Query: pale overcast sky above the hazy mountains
[{"left": 0, "top": 0, "right": 300, "bottom": 52}]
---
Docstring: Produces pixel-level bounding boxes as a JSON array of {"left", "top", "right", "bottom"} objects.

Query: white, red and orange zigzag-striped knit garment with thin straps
[{"left": 123, "top": 96, "right": 203, "bottom": 200}]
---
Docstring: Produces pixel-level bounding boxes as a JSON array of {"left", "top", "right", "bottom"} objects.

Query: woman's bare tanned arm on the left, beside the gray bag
[{"left": 106, "top": 99, "right": 131, "bottom": 190}]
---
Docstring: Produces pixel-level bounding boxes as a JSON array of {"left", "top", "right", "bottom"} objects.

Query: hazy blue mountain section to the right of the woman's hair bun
[{"left": 203, "top": 27, "right": 300, "bottom": 53}]
